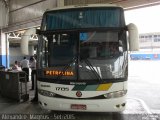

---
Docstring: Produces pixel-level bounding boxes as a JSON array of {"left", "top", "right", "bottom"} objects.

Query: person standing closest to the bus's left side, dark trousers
[{"left": 30, "top": 56, "right": 36, "bottom": 90}]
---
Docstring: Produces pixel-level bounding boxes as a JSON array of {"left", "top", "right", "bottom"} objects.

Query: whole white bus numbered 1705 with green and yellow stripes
[{"left": 37, "top": 4, "right": 138, "bottom": 112}]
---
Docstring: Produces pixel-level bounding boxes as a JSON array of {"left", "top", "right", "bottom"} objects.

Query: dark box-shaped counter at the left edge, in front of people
[{"left": 0, "top": 70, "right": 29, "bottom": 102}]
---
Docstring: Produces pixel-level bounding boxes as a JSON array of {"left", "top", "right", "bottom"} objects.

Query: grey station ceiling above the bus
[{"left": 3, "top": 0, "right": 160, "bottom": 39}]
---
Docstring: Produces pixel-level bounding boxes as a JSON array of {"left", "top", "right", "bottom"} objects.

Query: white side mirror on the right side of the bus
[{"left": 127, "top": 23, "right": 139, "bottom": 51}]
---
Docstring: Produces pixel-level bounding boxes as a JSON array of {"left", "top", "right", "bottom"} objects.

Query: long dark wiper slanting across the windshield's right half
[{"left": 82, "top": 58, "right": 102, "bottom": 81}]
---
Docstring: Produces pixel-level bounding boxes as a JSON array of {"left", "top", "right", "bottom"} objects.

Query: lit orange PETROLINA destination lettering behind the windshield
[{"left": 45, "top": 70, "right": 74, "bottom": 76}]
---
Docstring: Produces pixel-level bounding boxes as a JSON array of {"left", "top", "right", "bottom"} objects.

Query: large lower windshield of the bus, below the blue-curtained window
[{"left": 37, "top": 31, "right": 127, "bottom": 80}]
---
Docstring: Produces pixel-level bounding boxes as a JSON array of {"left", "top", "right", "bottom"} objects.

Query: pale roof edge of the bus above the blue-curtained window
[{"left": 46, "top": 4, "right": 122, "bottom": 12}]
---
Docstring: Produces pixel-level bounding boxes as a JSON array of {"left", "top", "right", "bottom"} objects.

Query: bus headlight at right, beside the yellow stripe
[{"left": 104, "top": 90, "right": 127, "bottom": 99}]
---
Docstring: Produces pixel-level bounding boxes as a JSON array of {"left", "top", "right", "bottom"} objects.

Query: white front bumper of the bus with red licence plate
[{"left": 38, "top": 94, "right": 126, "bottom": 112}]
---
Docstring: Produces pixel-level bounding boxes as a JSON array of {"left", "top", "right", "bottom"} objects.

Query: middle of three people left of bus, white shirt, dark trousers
[{"left": 20, "top": 57, "right": 29, "bottom": 82}]
